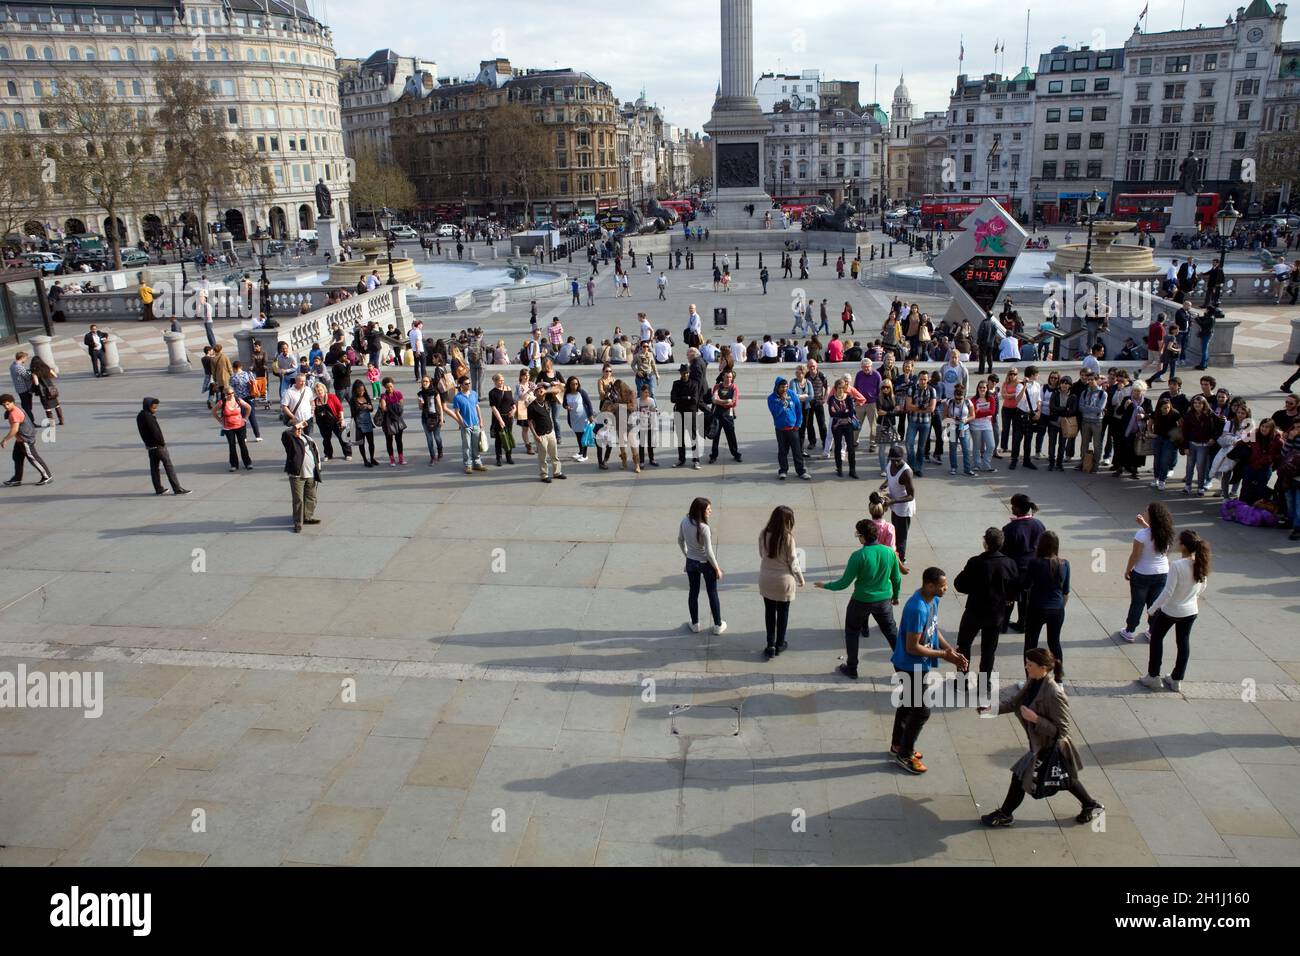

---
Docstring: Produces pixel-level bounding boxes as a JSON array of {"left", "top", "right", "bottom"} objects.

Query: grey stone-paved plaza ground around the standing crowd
[{"left": 0, "top": 256, "right": 1300, "bottom": 866}]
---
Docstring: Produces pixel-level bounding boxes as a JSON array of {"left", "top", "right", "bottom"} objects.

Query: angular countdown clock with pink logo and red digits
[{"left": 931, "top": 199, "right": 1028, "bottom": 329}]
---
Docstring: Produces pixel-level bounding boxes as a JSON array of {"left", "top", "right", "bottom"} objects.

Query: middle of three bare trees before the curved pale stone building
[{"left": 42, "top": 77, "right": 156, "bottom": 269}]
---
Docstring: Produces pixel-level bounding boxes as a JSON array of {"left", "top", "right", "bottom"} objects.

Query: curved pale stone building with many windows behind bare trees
[{"left": 0, "top": 0, "right": 350, "bottom": 243}]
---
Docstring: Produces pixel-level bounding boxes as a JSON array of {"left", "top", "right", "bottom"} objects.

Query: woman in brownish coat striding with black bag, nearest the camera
[{"left": 980, "top": 648, "right": 1106, "bottom": 826}]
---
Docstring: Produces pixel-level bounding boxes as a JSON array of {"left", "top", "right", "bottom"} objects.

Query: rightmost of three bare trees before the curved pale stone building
[{"left": 153, "top": 60, "right": 274, "bottom": 250}]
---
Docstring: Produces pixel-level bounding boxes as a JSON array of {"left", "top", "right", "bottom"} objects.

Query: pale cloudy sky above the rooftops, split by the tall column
[{"left": 319, "top": 0, "right": 1300, "bottom": 130}]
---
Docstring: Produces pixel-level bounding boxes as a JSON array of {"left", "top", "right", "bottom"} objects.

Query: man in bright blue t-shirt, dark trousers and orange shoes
[{"left": 889, "top": 567, "right": 966, "bottom": 774}]
